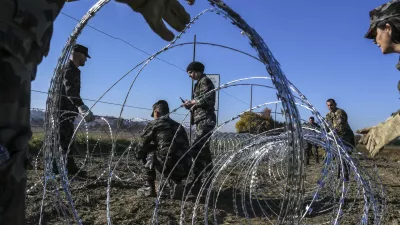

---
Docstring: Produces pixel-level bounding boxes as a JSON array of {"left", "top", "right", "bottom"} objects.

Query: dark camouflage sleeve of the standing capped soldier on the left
[{"left": 63, "top": 69, "right": 83, "bottom": 107}]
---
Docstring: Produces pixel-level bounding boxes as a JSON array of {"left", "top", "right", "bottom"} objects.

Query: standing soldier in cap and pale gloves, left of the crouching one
[{"left": 55, "top": 44, "right": 95, "bottom": 176}]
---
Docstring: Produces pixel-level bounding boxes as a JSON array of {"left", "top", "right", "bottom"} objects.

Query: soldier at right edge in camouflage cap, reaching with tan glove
[{"left": 356, "top": 0, "right": 400, "bottom": 156}]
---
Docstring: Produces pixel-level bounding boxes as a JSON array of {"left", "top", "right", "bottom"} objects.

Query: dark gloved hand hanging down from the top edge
[{"left": 116, "top": 0, "right": 195, "bottom": 41}]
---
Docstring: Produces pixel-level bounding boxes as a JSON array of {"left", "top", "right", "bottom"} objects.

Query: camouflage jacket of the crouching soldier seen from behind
[{"left": 136, "top": 116, "right": 189, "bottom": 163}]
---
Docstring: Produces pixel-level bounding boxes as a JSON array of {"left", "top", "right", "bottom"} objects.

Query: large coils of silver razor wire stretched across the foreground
[{"left": 32, "top": 0, "right": 386, "bottom": 224}]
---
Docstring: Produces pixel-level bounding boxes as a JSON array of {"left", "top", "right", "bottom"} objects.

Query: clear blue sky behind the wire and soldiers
[{"left": 32, "top": 0, "right": 400, "bottom": 131}]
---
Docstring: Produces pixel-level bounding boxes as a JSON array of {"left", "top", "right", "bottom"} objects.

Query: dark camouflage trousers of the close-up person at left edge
[{"left": 0, "top": 49, "right": 36, "bottom": 225}]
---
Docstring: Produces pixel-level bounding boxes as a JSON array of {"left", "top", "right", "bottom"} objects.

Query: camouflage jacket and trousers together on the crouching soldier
[{"left": 136, "top": 116, "right": 192, "bottom": 181}]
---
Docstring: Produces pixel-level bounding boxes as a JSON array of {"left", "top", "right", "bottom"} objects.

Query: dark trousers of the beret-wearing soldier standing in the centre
[{"left": 190, "top": 119, "right": 216, "bottom": 181}]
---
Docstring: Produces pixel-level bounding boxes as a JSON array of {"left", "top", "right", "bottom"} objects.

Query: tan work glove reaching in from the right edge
[{"left": 356, "top": 114, "right": 400, "bottom": 157}]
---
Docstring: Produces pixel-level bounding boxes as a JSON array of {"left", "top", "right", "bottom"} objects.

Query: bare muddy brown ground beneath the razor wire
[{"left": 27, "top": 143, "right": 400, "bottom": 225}]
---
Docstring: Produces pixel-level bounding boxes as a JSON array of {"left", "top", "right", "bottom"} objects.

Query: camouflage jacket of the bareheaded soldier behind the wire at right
[{"left": 325, "top": 108, "right": 355, "bottom": 146}]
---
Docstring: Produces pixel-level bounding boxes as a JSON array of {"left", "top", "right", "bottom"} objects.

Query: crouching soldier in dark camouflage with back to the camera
[{"left": 136, "top": 100, "right": 192, "bottom": 198}]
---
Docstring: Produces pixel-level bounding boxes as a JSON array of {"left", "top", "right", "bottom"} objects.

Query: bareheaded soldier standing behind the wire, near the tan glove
[{"left": 325, "top": 99, "right": 355, "bottom": 181}]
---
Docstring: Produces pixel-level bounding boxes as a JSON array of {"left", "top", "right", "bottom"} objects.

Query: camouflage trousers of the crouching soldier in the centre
[{"left": 143, "top": 147, "right": 192, "bottom": 183}]
